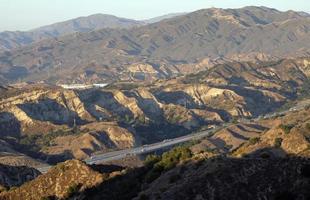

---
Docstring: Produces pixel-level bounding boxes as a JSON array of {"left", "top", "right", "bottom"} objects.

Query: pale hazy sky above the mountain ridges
[{"left": 0, "top": 0, "right": 310, "bottom": 31}]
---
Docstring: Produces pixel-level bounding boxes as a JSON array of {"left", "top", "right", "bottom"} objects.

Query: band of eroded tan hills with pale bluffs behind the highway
[{"left": 0, "top": 58, "right": 310, "bottom": 166}]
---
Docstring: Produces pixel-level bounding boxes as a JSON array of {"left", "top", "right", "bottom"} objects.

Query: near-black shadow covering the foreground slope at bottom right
[{"left": 74, "top": 148, "right": 310, "bottom": 200}]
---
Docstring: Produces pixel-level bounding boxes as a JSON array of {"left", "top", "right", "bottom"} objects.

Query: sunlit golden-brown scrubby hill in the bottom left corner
[{"left": 0, "top": 160, "right": 103, "bottom": 200}]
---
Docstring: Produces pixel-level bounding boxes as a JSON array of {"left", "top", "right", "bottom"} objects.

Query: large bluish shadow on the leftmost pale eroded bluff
[{"left": 18, "top": 98, "right": 86, "bottom": 126}]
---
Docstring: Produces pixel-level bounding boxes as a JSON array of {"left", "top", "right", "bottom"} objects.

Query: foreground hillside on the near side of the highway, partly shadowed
[{"left": 0, "top": 105, "right": 310, "bottom": 200}]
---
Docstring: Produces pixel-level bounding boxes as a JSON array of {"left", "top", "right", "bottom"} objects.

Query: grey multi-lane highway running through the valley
[{"left": 37, "top": 101, "right": 310, "bottom": 173}]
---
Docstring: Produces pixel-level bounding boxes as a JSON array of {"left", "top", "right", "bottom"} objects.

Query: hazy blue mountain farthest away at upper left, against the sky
[{"left": 0, "top": 14, "right": 144, "bottom": 50}]
